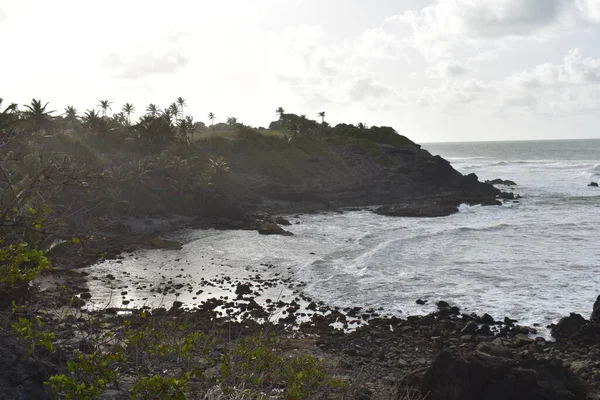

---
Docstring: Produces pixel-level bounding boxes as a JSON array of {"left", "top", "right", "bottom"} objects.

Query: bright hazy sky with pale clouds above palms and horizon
[{"left": 0, "top": 0, "right": 600, "bottom": 143}]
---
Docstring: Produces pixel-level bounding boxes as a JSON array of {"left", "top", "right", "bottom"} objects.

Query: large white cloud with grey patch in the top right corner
[{"left": 377, "top": 0, "right": 600, "bottom": 59}]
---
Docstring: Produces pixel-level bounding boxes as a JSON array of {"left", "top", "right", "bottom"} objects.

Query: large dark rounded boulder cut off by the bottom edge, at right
[{"left": 421, "top": 351, "right": 587, "bottom": 400}]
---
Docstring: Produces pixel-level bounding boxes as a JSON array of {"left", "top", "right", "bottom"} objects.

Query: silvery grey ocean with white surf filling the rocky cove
[{"left": 89, "top": 140, "right": 600, "bottom": 330}]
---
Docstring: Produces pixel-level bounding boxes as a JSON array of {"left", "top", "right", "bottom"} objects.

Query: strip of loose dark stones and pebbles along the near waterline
[{"left": 31, "top": 260, "right": 600, "bottom": 398}]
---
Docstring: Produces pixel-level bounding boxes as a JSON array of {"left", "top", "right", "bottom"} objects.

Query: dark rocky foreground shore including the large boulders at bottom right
[{"left": 0, "top": 266, "right": 600, "bottom": 400}]
